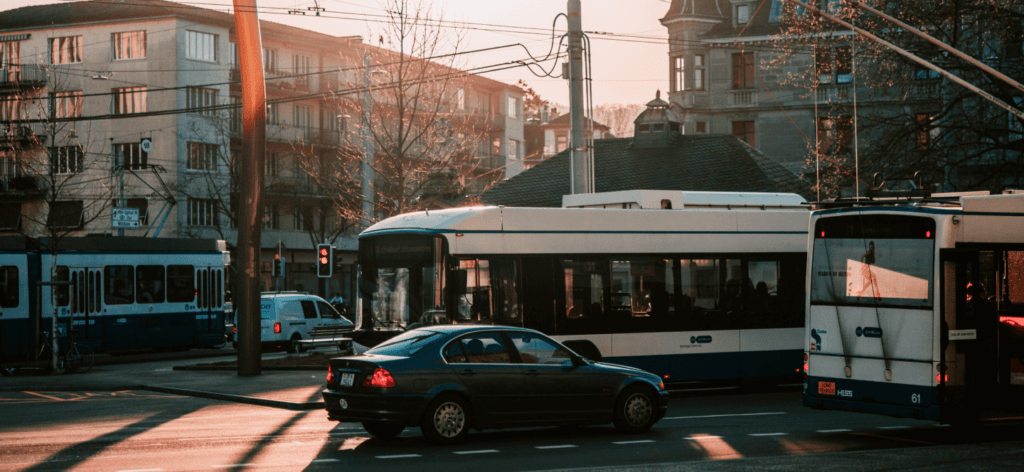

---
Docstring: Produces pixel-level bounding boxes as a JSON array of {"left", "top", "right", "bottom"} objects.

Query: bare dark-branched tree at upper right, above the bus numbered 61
[{"left": 776, "top": 0, "right": 1024, "bottom": 196}]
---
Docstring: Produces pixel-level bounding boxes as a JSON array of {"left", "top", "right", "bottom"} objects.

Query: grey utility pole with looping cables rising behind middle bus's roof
[{"left": 567, "top": 0, "right": 594, "bottom": 195}]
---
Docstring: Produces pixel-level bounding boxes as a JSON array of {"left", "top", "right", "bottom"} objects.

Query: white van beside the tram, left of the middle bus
[{"left": 259, "top": 292, "right": 355, "bottom": 352}]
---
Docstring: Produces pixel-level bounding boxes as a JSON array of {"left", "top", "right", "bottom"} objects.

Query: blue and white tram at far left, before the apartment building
[{"left": 0, "top": 237, "right": 229, "bottom": 358}]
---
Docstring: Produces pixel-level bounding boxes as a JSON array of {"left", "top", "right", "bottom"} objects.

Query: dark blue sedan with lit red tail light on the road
[{"left": 324, "top": 325, "right": 669, "bottom": 443}]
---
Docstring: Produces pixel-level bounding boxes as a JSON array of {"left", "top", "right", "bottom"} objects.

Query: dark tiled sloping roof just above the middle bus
[{"left": 480, "top": 134, "right": 810, "bottom": 207}]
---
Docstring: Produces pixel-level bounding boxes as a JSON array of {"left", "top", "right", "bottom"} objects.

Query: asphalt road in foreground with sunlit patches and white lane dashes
[{"left": 0, "top": 387, "right": 1024, "bottom": 472}]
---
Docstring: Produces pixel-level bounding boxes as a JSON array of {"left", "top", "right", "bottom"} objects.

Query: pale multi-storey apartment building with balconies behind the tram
[{"left": 0, "top": 0, "right": 523, "bottom": 299}]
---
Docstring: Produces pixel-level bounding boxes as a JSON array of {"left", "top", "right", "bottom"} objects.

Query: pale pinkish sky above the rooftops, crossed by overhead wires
[{"left": 0, "top": 0, "right": 670, "bottom": 105}]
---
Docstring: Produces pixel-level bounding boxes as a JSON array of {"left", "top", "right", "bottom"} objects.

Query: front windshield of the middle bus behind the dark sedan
[{"left": 359, "top": 234, "right": 445, "bottom": 329}]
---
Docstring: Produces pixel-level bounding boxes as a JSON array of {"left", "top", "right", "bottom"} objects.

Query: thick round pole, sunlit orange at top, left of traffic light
[{"left": 233, "top": 0, "right": 266, "bottom": 376}]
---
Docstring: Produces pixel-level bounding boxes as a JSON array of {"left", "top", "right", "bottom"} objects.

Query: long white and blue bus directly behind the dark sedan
[{"left": 357, "top": 190, "right": 810, "bottom": 382}]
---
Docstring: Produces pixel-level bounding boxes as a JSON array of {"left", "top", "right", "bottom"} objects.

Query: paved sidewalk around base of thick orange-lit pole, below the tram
[{"left": 0, "top": 349, "right": 327, "bottom": 410}]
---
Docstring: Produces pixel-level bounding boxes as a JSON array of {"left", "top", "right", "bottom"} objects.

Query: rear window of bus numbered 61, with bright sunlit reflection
[{"left": 811, "top": 215, "right": 935, "bottom": 308}]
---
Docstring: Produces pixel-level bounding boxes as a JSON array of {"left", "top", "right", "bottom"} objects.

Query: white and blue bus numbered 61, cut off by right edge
[{"left": 804, "top": 192, "right": 1024, "bottom": 424}]
